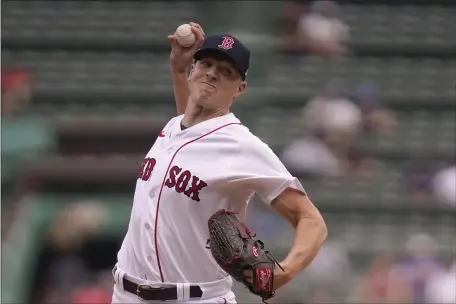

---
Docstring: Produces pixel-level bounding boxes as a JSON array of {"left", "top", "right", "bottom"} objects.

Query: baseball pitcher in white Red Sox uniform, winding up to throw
[{"left": 112, "top": 23, "right": 327, "bottom": 303}]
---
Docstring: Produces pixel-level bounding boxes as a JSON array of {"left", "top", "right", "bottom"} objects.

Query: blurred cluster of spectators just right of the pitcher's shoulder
[{"left": 281, "top": 81, "right": 395, "bottom": 177}]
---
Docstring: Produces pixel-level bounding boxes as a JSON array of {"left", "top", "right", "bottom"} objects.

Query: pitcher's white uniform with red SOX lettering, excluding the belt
[{"left": 113, "top": 113, "right": 304, "bottom": 303}]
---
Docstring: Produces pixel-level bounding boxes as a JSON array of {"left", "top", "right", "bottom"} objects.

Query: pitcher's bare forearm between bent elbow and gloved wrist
[{"left": 283, "top": 217, "right": 328, "bottom": 280}]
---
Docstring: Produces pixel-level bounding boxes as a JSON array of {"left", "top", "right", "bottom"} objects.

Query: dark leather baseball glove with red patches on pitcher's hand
[{"left": 207, "top": 209, "right": 283, "bottom": 302}]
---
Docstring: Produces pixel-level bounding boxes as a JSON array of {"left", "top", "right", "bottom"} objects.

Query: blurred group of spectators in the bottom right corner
[{"left": 353, "top": 234, "right": 456, "bottom": 303}]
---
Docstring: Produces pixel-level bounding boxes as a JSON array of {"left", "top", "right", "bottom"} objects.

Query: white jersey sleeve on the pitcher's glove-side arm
[{"left": 227, "top": 138, "right": 306, "bottom": 204}]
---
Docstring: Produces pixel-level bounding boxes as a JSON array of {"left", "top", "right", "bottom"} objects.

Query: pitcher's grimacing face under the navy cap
[{"left": 189, "top": 57, "right": 247, "bottom": 110}]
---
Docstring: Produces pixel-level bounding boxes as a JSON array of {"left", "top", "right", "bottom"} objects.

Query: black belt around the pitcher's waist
[{"left": 123, "top": 276, "right": 203, "bottom": 301}]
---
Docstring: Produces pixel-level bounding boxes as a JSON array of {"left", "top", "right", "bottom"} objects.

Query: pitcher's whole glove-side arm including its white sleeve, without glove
[{"left": 226, "top": 136, "right": 327, "bottom": 290}]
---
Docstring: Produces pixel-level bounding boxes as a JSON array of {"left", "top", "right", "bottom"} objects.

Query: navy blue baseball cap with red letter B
[{"left": 193, "top": 35, "right": 250, "bottom": 80}]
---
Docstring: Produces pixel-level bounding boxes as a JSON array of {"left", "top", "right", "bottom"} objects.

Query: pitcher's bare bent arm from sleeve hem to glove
[{"left": 271, "top": 188, "right": 328, "bottom": 290}]
